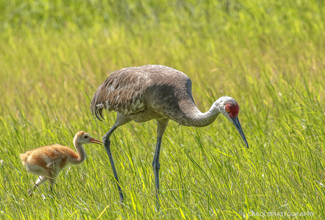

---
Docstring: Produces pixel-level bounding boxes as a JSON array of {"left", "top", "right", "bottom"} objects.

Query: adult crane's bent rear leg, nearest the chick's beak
[{"left": 103, "top": 113, "right": 131, "bottom": 203}]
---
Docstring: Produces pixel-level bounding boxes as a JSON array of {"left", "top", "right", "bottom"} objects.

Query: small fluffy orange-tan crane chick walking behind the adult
[{"left": 19, "top": 131, "right": 102, "bottom": 196}]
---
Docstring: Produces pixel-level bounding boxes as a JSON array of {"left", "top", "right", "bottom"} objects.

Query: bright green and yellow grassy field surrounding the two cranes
[{"left": 0, "top": 0, "right": 325, "bottom": 219}]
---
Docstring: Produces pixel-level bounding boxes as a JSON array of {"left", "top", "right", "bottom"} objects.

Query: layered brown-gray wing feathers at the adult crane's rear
[{"left": 91, "top": 68, "right": 150, "bottom": 120}]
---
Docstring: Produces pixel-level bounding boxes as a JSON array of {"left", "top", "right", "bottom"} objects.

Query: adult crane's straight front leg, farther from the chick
[{"left": 152, "top": 119, "right": 168, "bottom": 209}]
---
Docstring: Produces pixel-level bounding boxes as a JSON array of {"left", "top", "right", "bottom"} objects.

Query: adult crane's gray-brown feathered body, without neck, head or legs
[{"left": 91, "top": 65, "right": 208, "bottom": 126}]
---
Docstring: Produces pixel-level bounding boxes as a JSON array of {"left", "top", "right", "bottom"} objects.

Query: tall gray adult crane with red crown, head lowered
[{"left": 91, "top": 65, "right": 248, "bottom": 207}]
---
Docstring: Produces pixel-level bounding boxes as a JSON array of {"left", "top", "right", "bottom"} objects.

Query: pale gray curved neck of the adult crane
[{"left": 181, "top": 100, "right": 220, "bottom": 127}]
